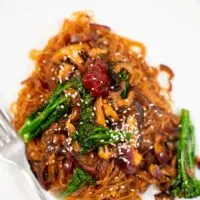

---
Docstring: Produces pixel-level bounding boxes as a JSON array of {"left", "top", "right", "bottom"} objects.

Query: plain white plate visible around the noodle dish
[{"left": 0, "top": 0, "right": 200, "bottom": 200}]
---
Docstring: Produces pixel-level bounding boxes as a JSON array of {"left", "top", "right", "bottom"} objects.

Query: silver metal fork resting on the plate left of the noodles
[{"left": 0, "top": 109, "right": 47, "bottom": 200}]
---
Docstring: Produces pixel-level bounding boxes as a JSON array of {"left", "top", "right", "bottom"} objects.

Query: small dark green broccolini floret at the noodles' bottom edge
[{"left": 60, "top": 168, "right": 95, "bottom": 197}]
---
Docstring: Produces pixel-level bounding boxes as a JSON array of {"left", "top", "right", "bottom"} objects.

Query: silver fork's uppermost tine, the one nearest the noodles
[{"left": 0, "top": 109, "right": 17, "bottom": 139}]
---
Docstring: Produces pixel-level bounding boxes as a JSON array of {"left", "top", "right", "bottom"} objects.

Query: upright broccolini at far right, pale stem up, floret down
[{"left": 171, "top": 109, "right": 200, "bottom": 198}]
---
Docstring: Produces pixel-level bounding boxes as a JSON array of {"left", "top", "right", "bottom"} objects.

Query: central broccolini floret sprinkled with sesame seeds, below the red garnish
[{"left": 73, "top": 93, "right": 131, "bottom": 153}]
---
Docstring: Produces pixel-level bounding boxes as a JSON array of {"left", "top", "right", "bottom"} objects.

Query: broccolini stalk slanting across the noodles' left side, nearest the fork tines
[{"left": 19, "top": 77, "right": 84, "bottom": 142}]
